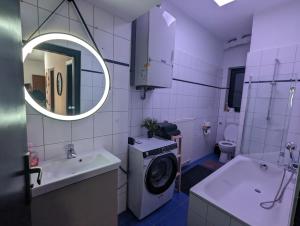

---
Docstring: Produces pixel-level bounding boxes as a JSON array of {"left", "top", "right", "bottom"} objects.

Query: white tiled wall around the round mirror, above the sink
[{"left": 21, "top": 0, "right": 131, "bottom": 212}]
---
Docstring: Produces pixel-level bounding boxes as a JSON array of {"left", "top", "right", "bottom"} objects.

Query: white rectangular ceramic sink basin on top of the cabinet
[{"left": 31, "top": 149, "right": 121, "bottom": 197}]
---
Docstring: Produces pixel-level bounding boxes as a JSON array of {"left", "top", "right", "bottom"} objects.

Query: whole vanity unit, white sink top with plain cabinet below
[{"left": 31, "top": 149, "right": 120, "bottom": 226}]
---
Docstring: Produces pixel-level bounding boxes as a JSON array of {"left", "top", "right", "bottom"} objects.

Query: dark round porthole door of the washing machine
[{"left": 145, "top": 153, "right": 177, "bottom": 194}]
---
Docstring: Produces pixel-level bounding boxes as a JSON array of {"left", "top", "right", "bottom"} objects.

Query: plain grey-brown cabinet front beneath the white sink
[{"left": 31, "top": 169, "right": 118, "bottom": 226}]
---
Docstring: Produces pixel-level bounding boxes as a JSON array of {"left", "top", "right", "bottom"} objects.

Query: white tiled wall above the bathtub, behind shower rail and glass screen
[{"left": 240, "top": 45, "right": 300, "bottom": 161}]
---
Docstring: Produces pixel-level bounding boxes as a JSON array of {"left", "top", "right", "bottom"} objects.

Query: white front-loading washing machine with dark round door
[{"left": 128, "top": 137, "right": 178, "bottom": 219}]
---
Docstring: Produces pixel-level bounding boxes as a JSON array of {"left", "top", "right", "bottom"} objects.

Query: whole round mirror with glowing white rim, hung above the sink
[{"left": 23, "top": 33, "right": 110, "bottom": 120}]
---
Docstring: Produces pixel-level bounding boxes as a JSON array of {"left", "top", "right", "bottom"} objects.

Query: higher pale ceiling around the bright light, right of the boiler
[{"left": 167, "top": 0, "right": 293, "bottom": 41}]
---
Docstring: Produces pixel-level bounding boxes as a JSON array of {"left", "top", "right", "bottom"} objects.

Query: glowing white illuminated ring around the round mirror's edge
[{"left": 22, "top": 33, "right": 110, "bottom": 121}]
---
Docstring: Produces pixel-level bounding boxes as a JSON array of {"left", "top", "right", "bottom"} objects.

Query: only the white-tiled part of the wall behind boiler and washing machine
[{"left": 130, "top": 49, "right": 220, "bottom": 162}]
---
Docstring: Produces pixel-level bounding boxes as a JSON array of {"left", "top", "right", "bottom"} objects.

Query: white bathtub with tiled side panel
[{"left": 188, "top": 156, "right": 296, "bottom": 226}]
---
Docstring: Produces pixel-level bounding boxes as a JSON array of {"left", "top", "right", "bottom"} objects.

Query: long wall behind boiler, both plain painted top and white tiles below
[{"left": 130, "top": 1, "right": 223, "bottom": 162}]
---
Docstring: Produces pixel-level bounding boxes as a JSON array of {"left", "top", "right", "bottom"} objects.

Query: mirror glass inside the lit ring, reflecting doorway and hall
[{"left": 24, "top": 40, "right": 105, "bottom": 115}]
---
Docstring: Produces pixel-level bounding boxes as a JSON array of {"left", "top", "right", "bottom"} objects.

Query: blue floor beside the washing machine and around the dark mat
[{"left": 119, "top": 154, "right": 218, "bottom": 226}]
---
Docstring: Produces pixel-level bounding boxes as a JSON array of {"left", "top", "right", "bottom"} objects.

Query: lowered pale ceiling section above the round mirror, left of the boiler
[{"left": 88, "top": 0, "right": 161, "bottom": 22}]
